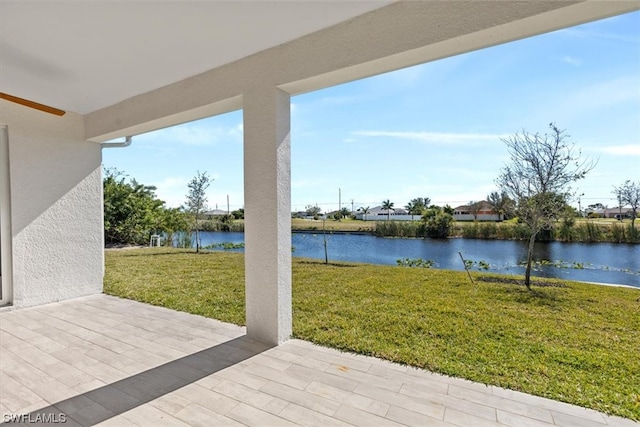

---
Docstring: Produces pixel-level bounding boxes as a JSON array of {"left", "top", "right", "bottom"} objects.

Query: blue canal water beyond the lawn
[{"left": 192, "top": 232, "right": 640, "bottom": 287}]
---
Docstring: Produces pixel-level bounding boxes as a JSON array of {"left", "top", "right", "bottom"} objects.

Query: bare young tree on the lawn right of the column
[{"left": 496, "top": 123, "right": 595, "bottom": 289}]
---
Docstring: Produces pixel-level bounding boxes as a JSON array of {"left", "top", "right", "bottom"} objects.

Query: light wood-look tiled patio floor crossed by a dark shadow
[{"left": 0, "top": 295, "right": 638, "bottom": 427}]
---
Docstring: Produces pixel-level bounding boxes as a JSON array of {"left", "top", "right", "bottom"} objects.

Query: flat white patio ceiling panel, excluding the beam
[{"left": 0, "top": 0, "right": 390, "bottom": 114}]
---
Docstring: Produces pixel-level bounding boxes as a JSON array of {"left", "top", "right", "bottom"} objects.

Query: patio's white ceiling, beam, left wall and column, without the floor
[{"left": 0, "top": 0, "right": 640, "bottom": 344}]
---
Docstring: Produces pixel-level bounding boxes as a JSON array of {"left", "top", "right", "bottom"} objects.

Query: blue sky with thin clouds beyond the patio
[{"left": 103, "top": 12, "right": 640, "bottom": 211}]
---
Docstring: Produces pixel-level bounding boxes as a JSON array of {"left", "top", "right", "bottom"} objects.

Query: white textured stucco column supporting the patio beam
[{"left": 243, "top": 87, "right": 292, "bottom": 345}]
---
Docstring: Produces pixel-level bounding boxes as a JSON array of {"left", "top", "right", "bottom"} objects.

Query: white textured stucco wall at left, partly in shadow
[{"left": 0, "top": 102, "right": 103, "bottom": 307}]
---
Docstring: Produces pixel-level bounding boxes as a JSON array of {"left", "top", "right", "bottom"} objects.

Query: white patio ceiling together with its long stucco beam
[{"left": 0, "top": 0, "right": 640, "bottom": 141}]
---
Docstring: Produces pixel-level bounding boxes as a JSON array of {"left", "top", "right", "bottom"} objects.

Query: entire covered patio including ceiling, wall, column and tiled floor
[{"left": 0, "top": 0, "right": 640, "bottom": 426}]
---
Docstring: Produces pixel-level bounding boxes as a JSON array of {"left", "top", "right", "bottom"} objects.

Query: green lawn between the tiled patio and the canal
[{"left": 105, "top": 249, "right": 640, "bottom": 420}]
